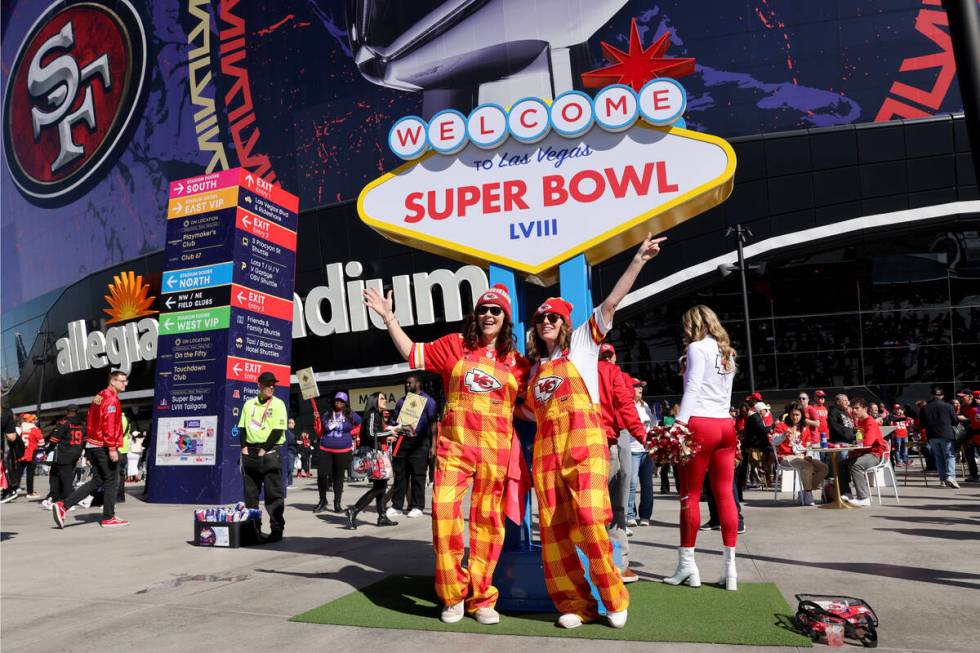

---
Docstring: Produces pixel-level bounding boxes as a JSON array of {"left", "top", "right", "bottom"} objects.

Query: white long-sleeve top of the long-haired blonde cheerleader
[{"left": 677, "top": 336, "right": 735, "bottom": 423}]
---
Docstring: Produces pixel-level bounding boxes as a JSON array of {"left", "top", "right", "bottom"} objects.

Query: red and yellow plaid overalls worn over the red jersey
[{"left": 432, "top": 349, "right": 526, "bottom": 612}]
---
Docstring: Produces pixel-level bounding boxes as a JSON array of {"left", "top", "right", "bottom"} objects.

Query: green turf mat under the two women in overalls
[{"left": 291, "top": 576, "right": 811, "bottom": 647}]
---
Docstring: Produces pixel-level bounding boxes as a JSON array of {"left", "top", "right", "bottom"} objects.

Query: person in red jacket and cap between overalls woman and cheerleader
[{"left": 599, "top": 343, "right": 646, "bottom": 583}]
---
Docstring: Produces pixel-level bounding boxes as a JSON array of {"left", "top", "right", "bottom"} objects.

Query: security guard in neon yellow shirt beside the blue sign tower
[{"left": 238, "top": 372, "right": 287, "bottom": 542}]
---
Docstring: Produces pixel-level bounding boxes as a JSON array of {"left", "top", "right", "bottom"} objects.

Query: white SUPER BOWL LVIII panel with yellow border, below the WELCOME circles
[{"left": 358, "top": 85, "right": 735, "bottom": 284}]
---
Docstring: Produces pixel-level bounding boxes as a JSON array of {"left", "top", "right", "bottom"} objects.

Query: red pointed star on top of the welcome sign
[{"left": 582, "top": 18, "right": 694, "bottom": 91}]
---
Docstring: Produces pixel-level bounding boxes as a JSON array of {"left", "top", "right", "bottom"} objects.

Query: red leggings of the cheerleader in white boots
[{"left": 679, "top": 417, "right": 738, "bottom": 547}]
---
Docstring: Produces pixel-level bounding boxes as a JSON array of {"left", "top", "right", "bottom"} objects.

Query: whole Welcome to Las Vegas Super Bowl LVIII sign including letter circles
[{"left": 358, "top": 78, "right": 735, "bottom": 283}]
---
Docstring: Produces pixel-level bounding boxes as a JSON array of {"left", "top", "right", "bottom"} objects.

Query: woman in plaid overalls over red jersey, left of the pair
[{"left": 364, "top": 284, "right": 527, "bottom": 625}]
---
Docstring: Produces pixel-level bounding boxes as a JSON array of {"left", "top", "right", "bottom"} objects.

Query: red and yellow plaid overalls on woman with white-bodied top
[{"left": 527, "top": 356, "right": 629, "bottom": 621}]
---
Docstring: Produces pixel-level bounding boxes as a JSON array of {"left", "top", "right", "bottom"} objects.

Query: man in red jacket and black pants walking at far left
[{"left": 51, "top": 370, "right": 129, "bottom": 528}]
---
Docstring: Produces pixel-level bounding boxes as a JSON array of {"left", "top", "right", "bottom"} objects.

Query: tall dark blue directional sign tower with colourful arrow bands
[{"left": 148, "top": 168, "right": 299, "bottom": 503}]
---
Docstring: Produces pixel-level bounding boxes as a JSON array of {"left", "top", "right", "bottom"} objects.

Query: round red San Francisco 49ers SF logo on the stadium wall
[{"left": 3, "top": 0, "right": 147, "bottom": 205}]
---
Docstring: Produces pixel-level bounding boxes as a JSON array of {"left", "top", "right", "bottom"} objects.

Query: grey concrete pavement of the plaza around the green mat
[{"left": 0, "top": 466, "right": 980, "bottom": 653}]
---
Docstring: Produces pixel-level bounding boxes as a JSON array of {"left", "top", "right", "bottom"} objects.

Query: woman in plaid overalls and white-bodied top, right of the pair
[{"left": 521, "top": 235, "right": 664, "bottom": 628}]
